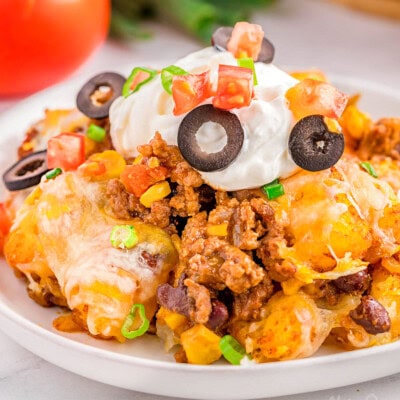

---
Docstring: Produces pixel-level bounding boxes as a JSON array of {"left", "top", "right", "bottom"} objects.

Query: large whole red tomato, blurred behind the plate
[{"left": 0, "top": 0, "right": 110, "bottom": 95}]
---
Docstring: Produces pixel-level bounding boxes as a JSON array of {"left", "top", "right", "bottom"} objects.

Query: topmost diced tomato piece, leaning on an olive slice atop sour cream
[{"left": 227, "top": 22, "right": 264, "bottom": 60}]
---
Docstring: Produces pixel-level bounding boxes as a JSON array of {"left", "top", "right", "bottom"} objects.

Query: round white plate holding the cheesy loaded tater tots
[{"left": 0, "top": 72, "right": 400, "bottom": 400}]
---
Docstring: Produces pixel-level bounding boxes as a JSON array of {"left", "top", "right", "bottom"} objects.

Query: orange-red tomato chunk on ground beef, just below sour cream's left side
[{"left": 121, "top": 164, "right": 167, "bottom": 197}]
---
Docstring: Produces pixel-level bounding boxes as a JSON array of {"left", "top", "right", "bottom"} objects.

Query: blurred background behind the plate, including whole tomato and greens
[{"left": 0, "top": 0, "right": 400, "bottom": 111}]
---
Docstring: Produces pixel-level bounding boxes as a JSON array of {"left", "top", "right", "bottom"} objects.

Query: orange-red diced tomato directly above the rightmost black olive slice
[{"left": 286, "top": 79, "right": 348, "bottom": 119}]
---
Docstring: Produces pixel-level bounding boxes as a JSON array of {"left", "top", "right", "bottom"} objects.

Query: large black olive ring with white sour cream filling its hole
[{"left": 178, "top": 104, "right": 244, "bottom": 172}]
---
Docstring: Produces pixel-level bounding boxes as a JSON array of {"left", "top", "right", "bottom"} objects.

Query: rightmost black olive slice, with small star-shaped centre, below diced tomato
[{"left": 289, "top": 115, "right": 344, "bottom": 171}]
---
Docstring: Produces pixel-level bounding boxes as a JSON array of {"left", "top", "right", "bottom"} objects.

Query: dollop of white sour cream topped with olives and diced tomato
[{"left": 110, "top": 47, "right": 298, "bottom": 191}]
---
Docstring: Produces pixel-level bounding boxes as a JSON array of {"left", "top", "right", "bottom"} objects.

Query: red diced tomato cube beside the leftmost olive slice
[{"left": 47, "top": 133, "right": 85, "bottom": 171}]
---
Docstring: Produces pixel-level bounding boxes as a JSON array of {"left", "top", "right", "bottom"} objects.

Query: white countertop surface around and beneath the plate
[{"left": 0, "top": 0, "right": 400, "bottom": 400}]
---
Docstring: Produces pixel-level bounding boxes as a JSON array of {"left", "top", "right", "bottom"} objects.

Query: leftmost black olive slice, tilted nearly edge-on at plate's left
[{"left": 3, "top": 150, "right": 49, "bottom": 191}]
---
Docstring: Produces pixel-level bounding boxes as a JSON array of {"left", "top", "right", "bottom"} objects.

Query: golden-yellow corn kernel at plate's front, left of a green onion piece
[{"left": 181, "top": 324, "right": 222, "bottom": 365}]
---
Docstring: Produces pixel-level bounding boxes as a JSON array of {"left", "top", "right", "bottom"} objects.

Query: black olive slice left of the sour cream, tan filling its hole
[{"left": 76, "top": 72, "right": 126, "bottom": 119}]
